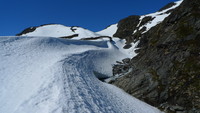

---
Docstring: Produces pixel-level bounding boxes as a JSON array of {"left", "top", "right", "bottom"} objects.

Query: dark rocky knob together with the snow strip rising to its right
[{"left": 112, "top": 0, "right": 183, "bottom": 40}]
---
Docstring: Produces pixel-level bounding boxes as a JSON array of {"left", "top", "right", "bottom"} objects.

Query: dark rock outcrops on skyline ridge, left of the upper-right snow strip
[{"left": 113, "top": 3, "right": 176, "bottom": 48}]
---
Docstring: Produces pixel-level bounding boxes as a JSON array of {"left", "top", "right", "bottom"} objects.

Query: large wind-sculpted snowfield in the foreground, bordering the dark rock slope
[{"left": 0, "top": 37, "right": 160, "bottom": 113}]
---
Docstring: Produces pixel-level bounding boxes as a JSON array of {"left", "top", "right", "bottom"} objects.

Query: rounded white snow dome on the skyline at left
[{"left": 22, "top": 24, "right": 99, "bottom": 39}]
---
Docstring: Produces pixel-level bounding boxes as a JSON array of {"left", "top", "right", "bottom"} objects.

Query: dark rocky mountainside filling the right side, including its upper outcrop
[{"left": 112, "top": 0, "right": 200, "bottom": 113}]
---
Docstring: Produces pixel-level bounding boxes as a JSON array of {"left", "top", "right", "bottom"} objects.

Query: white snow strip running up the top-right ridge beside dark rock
[{"left": 137, "top": 0, "right": 183, "bottom": 34}]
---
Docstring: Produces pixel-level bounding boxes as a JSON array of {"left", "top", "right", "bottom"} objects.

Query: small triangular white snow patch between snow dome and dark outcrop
[{"left": 96, "top": 24, "right": 118, "bottom": 37}]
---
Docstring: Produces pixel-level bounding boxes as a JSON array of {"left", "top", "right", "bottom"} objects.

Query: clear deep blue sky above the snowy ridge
[{"left": 0, "top": 0, "right": 177, "bottom": 36}]
